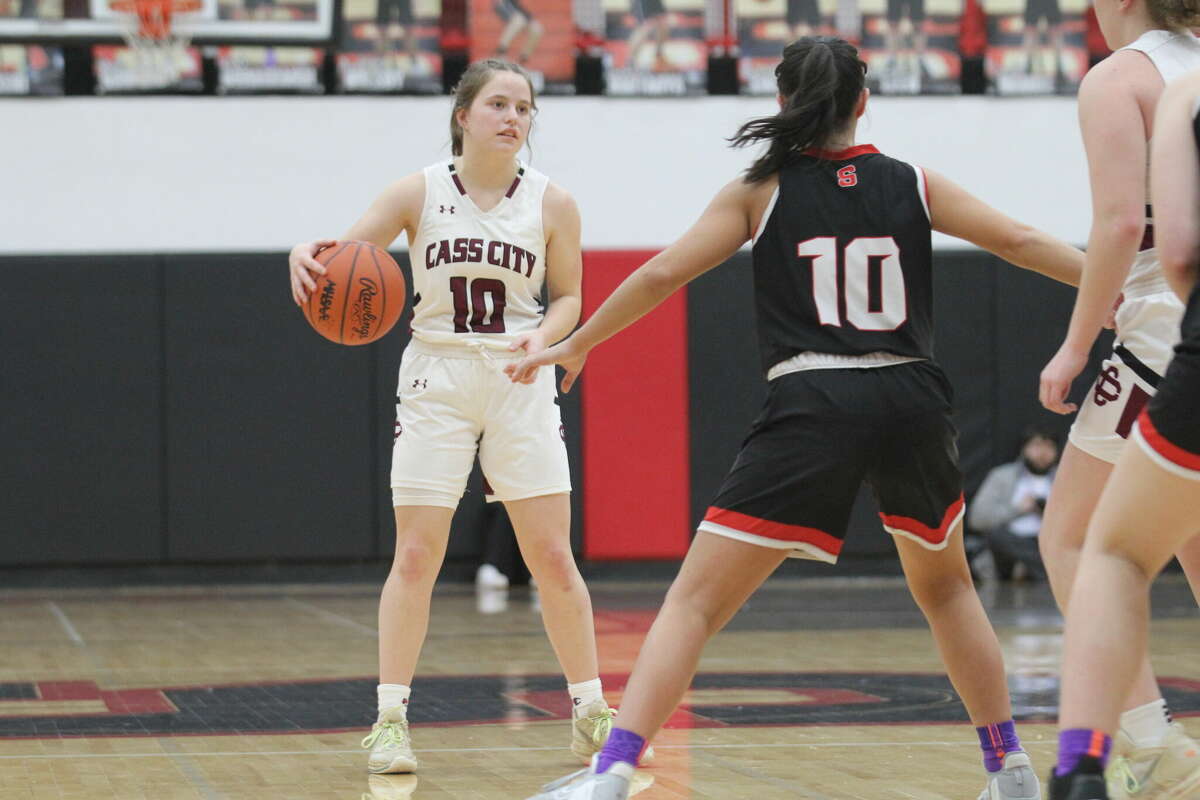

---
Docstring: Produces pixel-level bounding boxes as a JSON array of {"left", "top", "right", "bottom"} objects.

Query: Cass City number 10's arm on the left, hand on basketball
[{"left": 288, "top": 173, "right": 425, "bottom": 306}]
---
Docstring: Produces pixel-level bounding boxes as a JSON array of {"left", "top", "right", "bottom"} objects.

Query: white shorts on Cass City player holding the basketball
[{"left": 391, "top": 339, "right": 571, "bottom": 509}]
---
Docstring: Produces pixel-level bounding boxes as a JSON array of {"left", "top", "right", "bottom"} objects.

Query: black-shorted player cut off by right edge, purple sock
[{"left": 1050, "top": 67, "right": 1200, "bottom": 800}]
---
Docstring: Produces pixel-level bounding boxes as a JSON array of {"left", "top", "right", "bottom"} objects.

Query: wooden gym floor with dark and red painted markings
[{"left": 0, "top": 576, "right": 1200, "bottom": 800}]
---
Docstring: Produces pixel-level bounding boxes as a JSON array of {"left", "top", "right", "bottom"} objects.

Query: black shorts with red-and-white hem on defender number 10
[{"left": 700, "top": 361, "right": 964, "bottom": 564}]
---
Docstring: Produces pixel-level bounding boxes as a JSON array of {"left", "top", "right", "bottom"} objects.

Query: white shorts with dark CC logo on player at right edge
[{"left": 1069, "top": 291, "right": 1183, "bottom": 464}]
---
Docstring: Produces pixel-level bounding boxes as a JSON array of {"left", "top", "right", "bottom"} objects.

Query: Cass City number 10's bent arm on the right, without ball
[{"left": 509, "top": 184, "right": 583, "bottom": 384}]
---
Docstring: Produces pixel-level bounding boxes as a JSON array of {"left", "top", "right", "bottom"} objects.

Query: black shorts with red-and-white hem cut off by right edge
[{"left": 1133, "top": 285, "right": 1200, "bottom": 481}]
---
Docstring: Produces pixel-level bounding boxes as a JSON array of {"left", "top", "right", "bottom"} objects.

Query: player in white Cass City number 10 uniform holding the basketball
[{"left": 289, "top": 60, "right": 613, "bottom": 772}]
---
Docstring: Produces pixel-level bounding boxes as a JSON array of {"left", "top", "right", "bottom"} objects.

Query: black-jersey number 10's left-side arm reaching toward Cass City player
[{"left": 505, "top": 178, "right": 762, "bottom": 392}]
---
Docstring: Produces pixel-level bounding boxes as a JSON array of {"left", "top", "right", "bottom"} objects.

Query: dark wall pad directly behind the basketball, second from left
[{"left": 163, "top": 254, "right": 377, "bottom": 561}]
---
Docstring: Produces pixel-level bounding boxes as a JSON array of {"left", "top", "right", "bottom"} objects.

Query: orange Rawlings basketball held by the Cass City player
[{"left": 302, "top": 241, "right": 404, "bottom": 344}]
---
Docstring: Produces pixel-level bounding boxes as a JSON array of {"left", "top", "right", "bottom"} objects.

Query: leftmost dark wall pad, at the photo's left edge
[{"left": 0, "top": 255, "right": 164, "bottom": 564}]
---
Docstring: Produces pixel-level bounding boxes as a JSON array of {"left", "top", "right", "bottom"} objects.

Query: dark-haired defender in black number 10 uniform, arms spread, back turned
[{"left": 508, "top": 37, "right": 1082, "bottom": 800}]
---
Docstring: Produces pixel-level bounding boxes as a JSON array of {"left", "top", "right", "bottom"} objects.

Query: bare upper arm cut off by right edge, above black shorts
[{"left": 1150, "top": 71, "right": 1200, "bottom": 302}]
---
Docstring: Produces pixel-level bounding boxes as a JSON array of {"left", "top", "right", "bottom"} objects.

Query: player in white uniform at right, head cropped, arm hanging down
[{"left": 1039, "top": 0, "right": 1200, "bottom": 799}]
